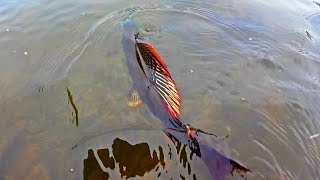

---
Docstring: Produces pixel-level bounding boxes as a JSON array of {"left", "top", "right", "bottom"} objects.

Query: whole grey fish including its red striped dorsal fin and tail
[{"left": 121, "top": 19, "right": 251, "bottom": 179}]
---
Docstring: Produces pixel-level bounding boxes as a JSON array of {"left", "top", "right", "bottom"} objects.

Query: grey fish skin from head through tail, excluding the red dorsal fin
[{"left": 121, "top": 19, "right": 251, "bottom": 180}]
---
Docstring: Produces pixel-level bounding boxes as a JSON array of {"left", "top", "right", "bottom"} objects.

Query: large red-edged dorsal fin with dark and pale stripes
[{"left": 137, "top": 42, "right": 181, "bottom": 117}]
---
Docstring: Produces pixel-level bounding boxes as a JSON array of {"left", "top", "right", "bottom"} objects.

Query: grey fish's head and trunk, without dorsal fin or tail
[{"left": 122, "top": 20, "right": 182, "bottom": 128}]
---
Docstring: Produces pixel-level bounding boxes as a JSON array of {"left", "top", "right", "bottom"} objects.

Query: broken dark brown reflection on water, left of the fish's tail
[{"left": 83, "top": 138, "right": 165, "bottom": 179}]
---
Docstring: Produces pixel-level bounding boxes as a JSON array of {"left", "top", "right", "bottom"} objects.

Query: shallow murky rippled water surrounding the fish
[{"left": 0, "top": 0, "right": 320, "bottom": 179}]
